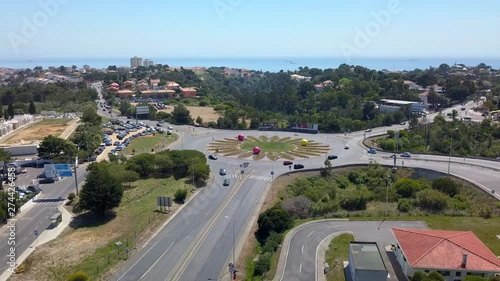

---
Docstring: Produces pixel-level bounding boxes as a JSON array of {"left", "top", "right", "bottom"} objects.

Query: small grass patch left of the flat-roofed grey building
[{"left": 325, "top": 233, "right": 354, "bottom": 281}]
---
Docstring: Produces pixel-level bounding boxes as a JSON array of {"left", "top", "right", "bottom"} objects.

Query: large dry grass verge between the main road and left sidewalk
[{"left": 27, "top": 177, "right": 190, "bottom": 280}]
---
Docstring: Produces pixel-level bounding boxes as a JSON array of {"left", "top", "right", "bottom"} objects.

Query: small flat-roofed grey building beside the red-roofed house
[{"left": 348, "top": 241, "right": 389, "bottom": 281}]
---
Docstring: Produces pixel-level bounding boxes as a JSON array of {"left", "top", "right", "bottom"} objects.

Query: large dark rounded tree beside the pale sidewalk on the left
[{"left": 79, "top": 163, "right": 123, "bottom": 216}]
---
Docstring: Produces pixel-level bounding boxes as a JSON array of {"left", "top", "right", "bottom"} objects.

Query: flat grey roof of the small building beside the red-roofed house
[{"left": 349, "top": 241, "right": 387, "bottom": 270}]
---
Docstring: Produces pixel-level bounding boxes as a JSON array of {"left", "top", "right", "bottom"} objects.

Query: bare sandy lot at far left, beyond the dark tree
[{"left": 2, "top": 119, "right": 80, "bottom": 145}]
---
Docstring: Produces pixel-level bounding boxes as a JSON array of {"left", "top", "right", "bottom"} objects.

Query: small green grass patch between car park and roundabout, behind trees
[{"left": 122, "top": 134, "right": 179, "bottom": 156}]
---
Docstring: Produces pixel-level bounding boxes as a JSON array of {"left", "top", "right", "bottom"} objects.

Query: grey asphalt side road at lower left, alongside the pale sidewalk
[{"left": 0, "top": 165, "right": 86, "bottom": 273}]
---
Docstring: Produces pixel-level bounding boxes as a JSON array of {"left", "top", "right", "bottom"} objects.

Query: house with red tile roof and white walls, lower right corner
[{"left": 392, "top": 228, "right": 500, "bottom": 281}]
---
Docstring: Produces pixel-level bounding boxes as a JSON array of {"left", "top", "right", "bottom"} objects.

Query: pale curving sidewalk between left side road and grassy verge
[{"left": 0, "top": 202, "right": 72, "bottom": 281}]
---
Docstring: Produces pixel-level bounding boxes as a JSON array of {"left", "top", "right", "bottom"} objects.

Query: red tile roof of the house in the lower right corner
[{"left": 392, "top": 228, "right": 500, "bottom": 272}]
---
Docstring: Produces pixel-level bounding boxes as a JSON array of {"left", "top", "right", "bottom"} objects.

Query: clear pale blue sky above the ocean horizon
[{"left": 0, "top": 0, "right": 500, "bottom": 59}]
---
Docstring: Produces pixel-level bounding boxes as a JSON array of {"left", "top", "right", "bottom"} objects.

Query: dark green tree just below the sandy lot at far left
[{"left": 38, "top": 135, "right": 77, "bottom": 162}]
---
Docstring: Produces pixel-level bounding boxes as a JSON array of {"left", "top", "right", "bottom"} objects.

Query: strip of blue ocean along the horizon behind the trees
[{"left": 0, "top": 57, "right": 500, "bottom": 72}]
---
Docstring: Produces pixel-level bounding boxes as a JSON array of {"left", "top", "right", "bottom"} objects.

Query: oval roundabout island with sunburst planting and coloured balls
[{"left": 206, "top": 135, "right": 331, "bottom": 161}]
